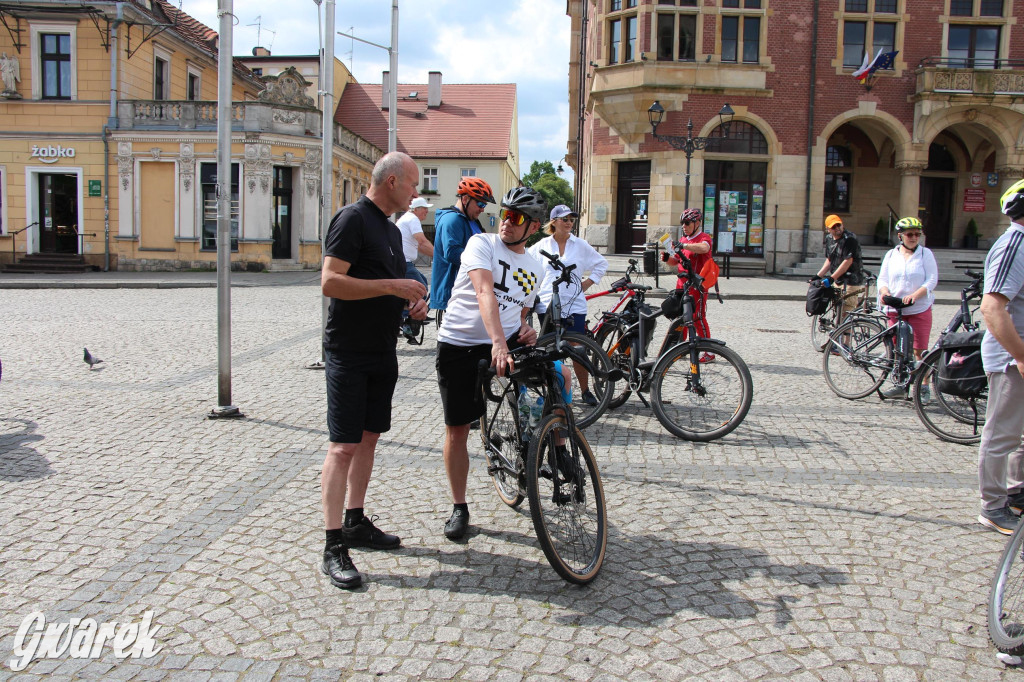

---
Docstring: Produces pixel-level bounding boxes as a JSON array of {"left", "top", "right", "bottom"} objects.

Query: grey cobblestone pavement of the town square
[{"left": 0, "top": 283, "right": 1006, "bottom": 680}]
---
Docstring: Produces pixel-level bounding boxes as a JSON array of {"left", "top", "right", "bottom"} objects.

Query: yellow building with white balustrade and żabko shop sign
[{"left": 0, "top": 0, "right": 382, "bottom": 270}]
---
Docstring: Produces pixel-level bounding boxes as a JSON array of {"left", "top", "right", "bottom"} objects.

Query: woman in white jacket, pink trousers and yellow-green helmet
[{"left": 879, "top": 218, "right": 939, "bottom": 397}]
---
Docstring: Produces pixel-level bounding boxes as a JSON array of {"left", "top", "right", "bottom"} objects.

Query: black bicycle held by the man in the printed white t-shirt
[{"left": 480, "top": 254, "right": 608, "bottom": 585}]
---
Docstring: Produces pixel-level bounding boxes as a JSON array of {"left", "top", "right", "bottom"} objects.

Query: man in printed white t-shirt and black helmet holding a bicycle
[{"left": 434, "top": 187, "right": 548, "bottom": 540}]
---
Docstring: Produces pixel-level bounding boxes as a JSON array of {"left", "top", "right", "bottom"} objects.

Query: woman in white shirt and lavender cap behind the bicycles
[{"left": 529, "top": 204, "right": 608, "bottom": 406}]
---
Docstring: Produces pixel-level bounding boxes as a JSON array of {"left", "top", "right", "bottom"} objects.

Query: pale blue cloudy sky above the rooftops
[{"left": 185, "top": 0, "right": 572, "bottom": 183}]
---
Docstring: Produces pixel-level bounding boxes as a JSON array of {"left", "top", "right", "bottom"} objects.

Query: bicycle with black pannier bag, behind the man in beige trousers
[{"left": 913, "top": 270, "right": 988, "bottom": 445}]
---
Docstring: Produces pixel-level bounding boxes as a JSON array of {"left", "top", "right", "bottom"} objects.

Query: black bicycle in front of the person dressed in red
[{"left": 598, "top": 253, "right": 754, "bottom": 441}]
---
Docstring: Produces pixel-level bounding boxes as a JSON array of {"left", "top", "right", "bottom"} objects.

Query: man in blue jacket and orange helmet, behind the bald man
[{"left": 430, "top": 176, "right": 495, "bottom": 328}]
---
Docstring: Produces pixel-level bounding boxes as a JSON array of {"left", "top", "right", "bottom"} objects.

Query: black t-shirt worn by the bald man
[{"left": 324, "top": 192, "right": 406, "bottom": 352}]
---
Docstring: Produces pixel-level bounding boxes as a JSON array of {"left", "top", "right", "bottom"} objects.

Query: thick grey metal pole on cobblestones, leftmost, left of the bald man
[{"left": 210, "top": 0, "right": 243, "bottom": 419}]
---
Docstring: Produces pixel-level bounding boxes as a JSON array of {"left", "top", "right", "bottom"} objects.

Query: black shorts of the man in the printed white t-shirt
[{"left": 434, "top": 331, "right": 522, "bottom": 426}]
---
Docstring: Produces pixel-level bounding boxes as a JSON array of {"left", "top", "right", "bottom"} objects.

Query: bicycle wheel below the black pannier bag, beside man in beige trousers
[{"left": 913, "top": 348, "right": 988, "bottom": 445}]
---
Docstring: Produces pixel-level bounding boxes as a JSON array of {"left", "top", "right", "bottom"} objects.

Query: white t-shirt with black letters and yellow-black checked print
[{"left": 437, "top": 232, "right": 544, "bottom": 346}]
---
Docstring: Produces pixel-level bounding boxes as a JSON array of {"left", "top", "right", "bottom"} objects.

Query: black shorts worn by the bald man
[{"left": 324, "top": 349, "right": 398, "bottom": 442}]
